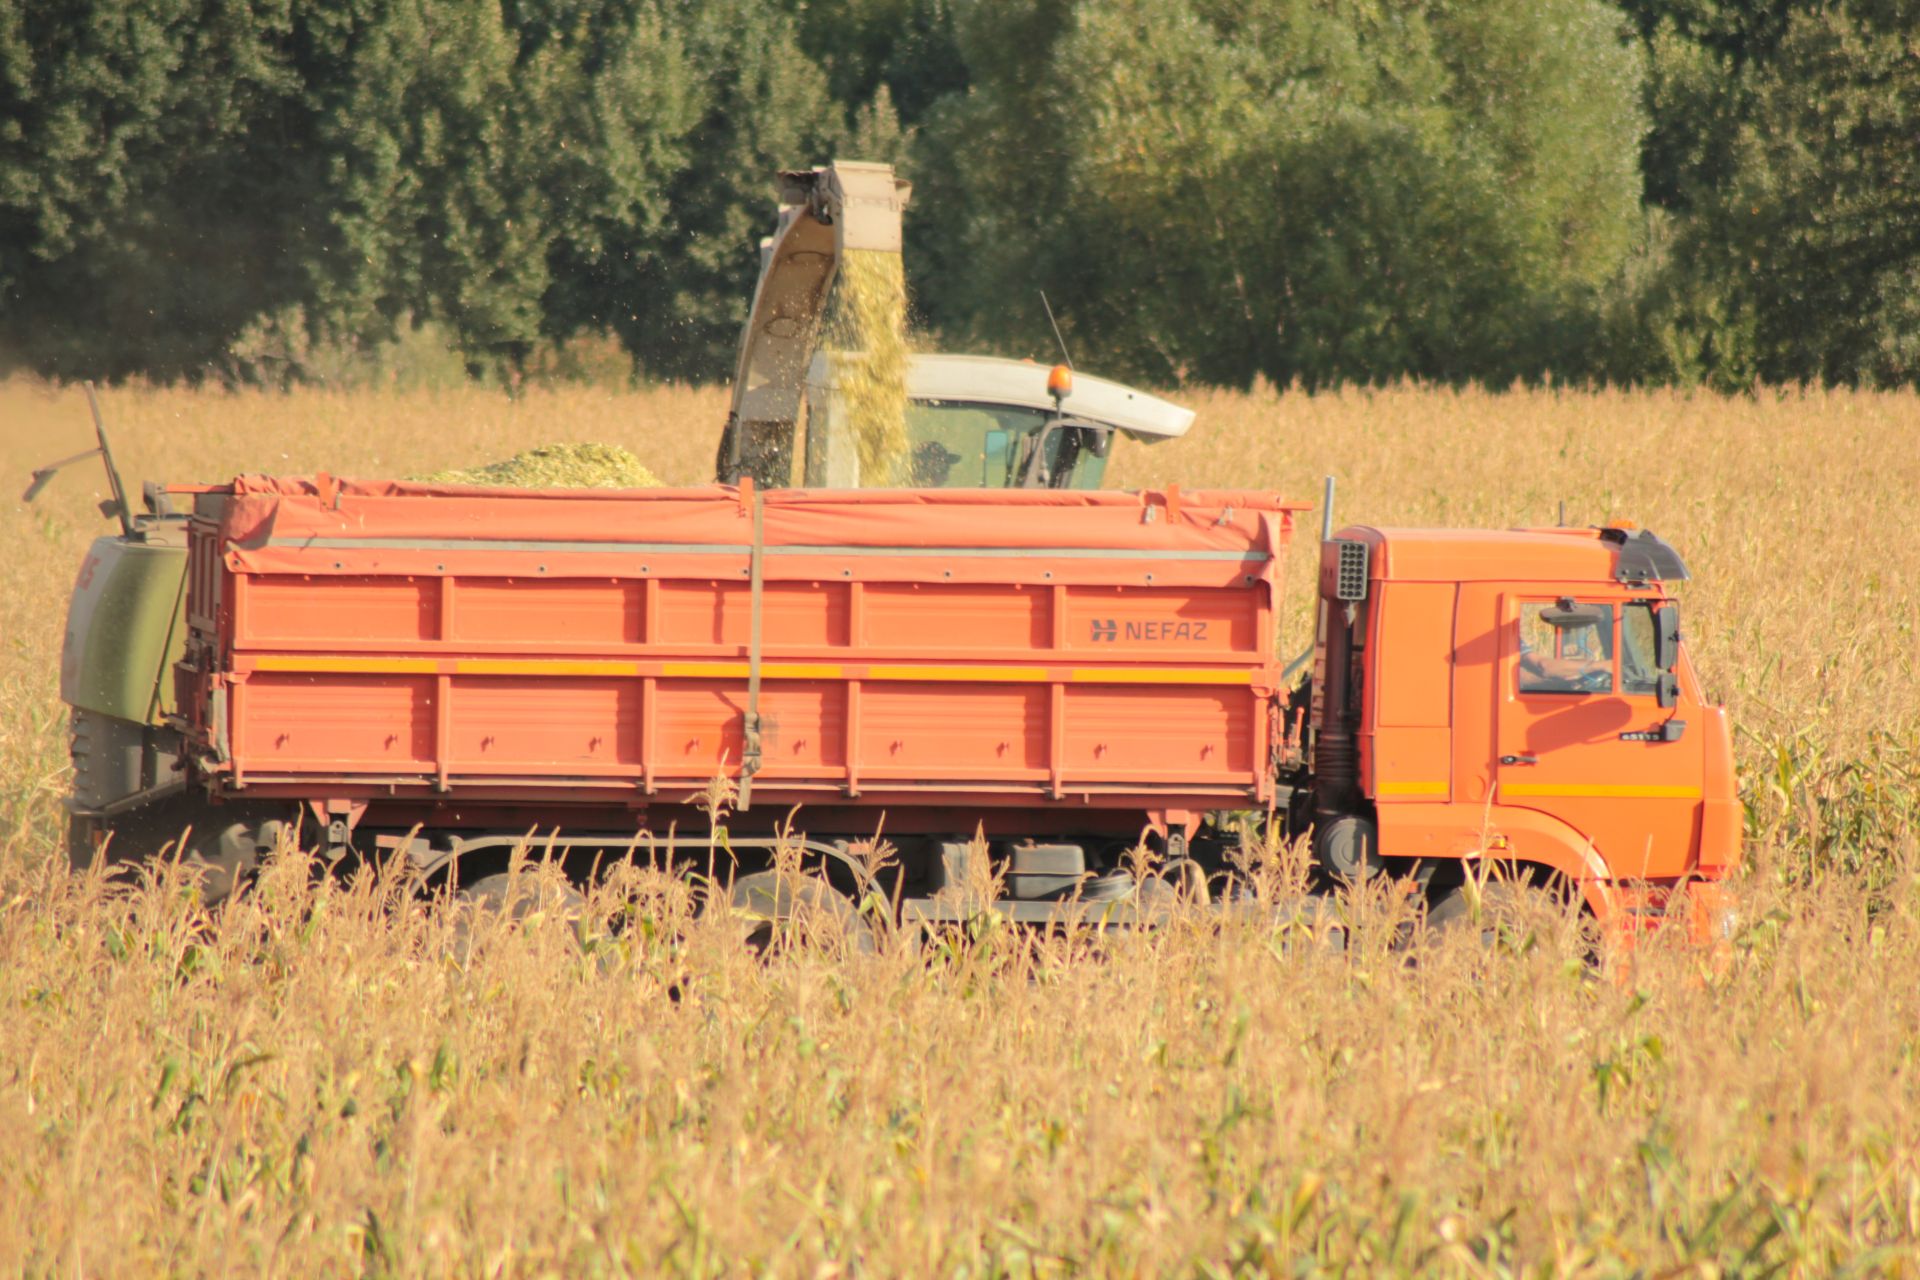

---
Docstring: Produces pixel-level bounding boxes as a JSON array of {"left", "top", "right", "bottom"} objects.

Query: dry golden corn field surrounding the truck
[{"left": 0, "top": 380, "right": 1920, "bottom": 1276}]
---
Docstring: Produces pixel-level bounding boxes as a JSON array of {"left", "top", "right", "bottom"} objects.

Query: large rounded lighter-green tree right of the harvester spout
[{"left": 922, "top": 0, "right": 1642, "bottom": 384}]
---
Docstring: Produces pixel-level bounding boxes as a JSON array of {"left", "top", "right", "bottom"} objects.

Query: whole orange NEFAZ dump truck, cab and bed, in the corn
[{"left": 67, "top": 476, "right": 1740, "bottom": 936}]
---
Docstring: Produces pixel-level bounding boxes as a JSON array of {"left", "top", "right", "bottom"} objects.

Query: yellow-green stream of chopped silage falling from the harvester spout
[{"left": 829, "top": 249, "right": 908, "bottom": 487}]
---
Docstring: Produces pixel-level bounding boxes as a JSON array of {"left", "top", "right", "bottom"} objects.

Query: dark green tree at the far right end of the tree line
[{"left": 1638, "top": 0, "right": 1920, "bottom": 388}]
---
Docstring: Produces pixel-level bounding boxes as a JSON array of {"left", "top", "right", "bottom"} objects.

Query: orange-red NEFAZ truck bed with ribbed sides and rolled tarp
[{"left": 177, "top": 476, "right": 1298, "bottom": 810}]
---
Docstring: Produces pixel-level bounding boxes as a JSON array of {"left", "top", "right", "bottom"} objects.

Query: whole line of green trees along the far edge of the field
[{"left": 0, "top": 0, "right": 1920, "bottom": 388}]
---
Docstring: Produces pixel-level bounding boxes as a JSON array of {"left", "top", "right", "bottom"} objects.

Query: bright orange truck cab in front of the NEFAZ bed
[{"left": 1311, "top": 526, "right": 1741, "bottom": 932}]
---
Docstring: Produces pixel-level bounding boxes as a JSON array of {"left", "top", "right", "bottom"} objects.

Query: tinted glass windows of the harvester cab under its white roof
[{"left": 906, "top": 401, "right": 1106, "bottom": 489}]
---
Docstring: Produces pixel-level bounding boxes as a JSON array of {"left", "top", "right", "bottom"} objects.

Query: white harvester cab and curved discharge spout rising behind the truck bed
[{"left": 714, "top": 161, "right": 1194, "bottom": 489}]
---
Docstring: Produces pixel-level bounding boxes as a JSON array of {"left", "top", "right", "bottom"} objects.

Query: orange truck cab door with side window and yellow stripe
[{"left": 1494, "top": 591, "right": 1705, "bottom": 879}]
